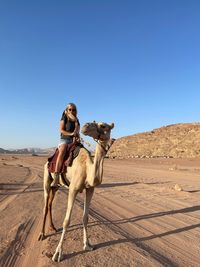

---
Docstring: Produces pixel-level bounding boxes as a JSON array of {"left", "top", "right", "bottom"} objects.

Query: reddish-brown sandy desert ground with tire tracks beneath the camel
[{"left": 0, "top": 155, "right": 200, "bottom": 267}]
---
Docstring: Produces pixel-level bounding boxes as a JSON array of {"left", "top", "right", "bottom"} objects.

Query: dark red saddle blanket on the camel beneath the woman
[{"left": 48, "top": 142, "right": 83, "bottom": 173}]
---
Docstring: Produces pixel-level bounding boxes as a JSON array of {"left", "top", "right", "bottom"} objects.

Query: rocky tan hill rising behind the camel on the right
[{"left": 108, "top": 122, "right": 200, "bottom": 158}]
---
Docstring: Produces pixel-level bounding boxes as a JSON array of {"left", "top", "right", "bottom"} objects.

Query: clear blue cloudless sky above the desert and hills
[{"left": 0, "top": 0, "right": 200, "bottom": 148}]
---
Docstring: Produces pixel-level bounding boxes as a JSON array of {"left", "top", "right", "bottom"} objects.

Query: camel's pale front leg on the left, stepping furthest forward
[{"left": 52, "top": 189, "right": 78, "bottom": 262}]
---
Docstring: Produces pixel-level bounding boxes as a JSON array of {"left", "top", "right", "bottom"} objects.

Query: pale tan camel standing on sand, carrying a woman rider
[{"left": 38, "top": 121, "right": 114, "bottom": 262}]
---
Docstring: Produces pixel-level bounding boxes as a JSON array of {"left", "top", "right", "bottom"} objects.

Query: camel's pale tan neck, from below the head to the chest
[{"left": 87, "top": 143, "right": 106, "bottom": 186}]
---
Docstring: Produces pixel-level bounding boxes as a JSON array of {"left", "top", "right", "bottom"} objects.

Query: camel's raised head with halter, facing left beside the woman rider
[{"left": 81, "top": 121, "right": 114, "bottom": 141}]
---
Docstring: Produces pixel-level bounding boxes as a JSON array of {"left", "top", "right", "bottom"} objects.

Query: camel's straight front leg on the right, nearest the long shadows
[{"left": 83, "top": 187, "right": 94, "bottom": 251}]
